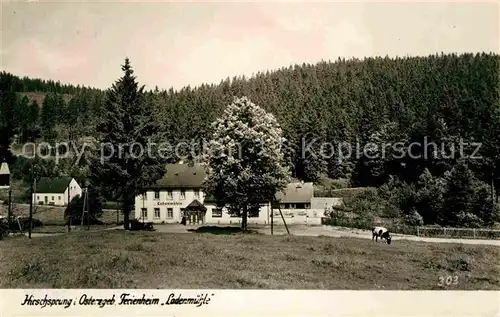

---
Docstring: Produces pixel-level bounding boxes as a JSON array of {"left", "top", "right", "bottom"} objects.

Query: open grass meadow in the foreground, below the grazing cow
[{"left": 0, "top": 230, "right": 500, "bottom": 290}]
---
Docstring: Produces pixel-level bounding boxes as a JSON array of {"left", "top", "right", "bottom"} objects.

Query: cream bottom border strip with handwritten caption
[{"left": 0, "top": 289, "right": 500, "bottom": 317}]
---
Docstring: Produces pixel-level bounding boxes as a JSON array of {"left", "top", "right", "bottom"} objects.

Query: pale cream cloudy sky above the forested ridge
[{"left": 0, "top": 0, "right": 500, "bottom": 89}]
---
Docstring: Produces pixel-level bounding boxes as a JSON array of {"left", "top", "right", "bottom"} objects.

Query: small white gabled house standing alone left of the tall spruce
[{"left": 33, "top": 177, "right": 82, "bottom": 206}]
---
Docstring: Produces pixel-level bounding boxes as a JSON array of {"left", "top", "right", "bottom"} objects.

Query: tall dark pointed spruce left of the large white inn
[{"left": 89, "top": 58, "right": 164, "bottom": 230}]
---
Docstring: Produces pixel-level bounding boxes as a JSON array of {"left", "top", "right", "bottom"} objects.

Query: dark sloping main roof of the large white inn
[{"left": 153, "top": 164, "right": 206, "bottom": 189}]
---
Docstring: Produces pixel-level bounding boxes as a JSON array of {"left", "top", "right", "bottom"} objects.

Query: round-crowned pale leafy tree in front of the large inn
[{"left": 203, "top": 97, "right": 289, "bottom": 230}]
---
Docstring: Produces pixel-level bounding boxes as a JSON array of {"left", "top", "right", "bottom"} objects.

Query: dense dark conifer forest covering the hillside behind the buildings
[{"left": 0, "top": 53, "right": 500, "bottom": 226}]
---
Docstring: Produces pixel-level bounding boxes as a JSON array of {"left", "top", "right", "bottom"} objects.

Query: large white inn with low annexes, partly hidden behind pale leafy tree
[{"left": 135, "top": 164, "right": 341, "bottom": 225}]
